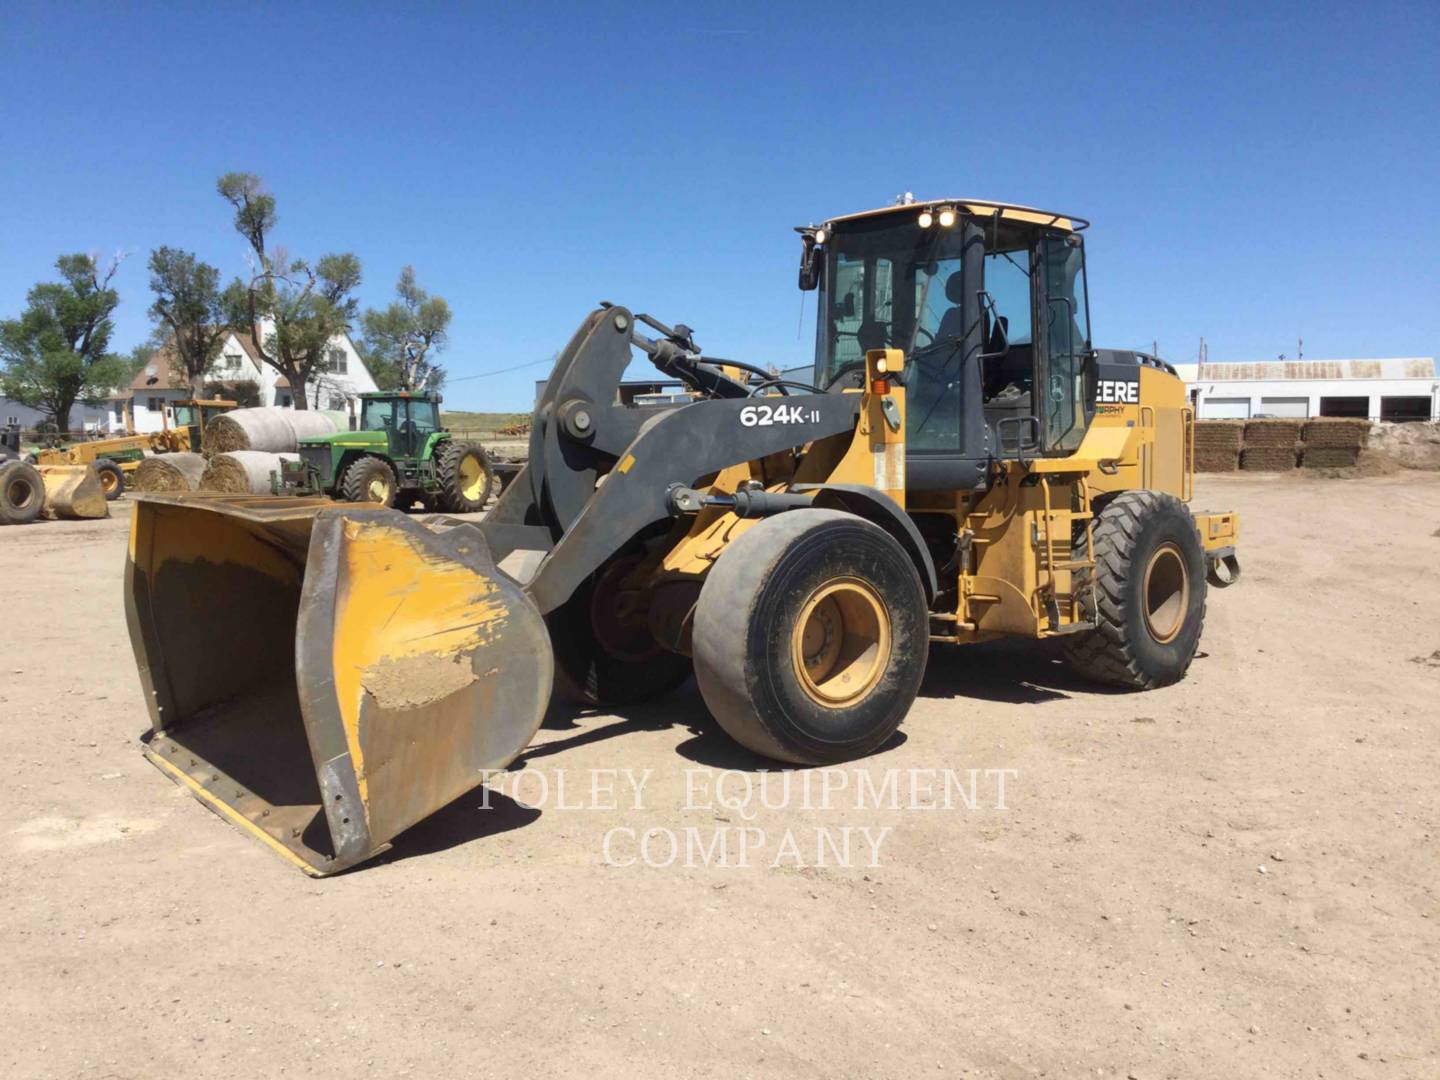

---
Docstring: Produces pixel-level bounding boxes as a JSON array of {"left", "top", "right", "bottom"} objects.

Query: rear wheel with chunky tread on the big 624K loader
[{"left": 1066, "top": 491, "right": 1205, "bottom": 690}]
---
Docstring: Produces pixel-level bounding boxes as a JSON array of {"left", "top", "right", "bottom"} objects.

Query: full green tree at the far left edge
[{"left": 0, "top": 255, "right": 130, "bottom": 432}]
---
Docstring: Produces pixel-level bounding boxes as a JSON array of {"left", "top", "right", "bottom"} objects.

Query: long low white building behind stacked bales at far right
[{"left": 1175, "top": 356, "right": 1440, "bottom": 422}]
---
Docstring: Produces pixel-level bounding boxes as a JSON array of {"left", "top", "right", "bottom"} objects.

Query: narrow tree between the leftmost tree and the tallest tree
[{"left": 150, "top": 248, "right": 230, "bottom": 397}]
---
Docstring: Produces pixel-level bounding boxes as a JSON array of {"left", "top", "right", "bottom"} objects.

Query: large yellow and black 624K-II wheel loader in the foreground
[{"left": 127, "top": 200, "right": 1238, "bottom": 876}]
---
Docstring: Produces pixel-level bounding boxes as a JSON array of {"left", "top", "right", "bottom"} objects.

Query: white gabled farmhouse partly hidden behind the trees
[{"left": 120, "top": 327, "right": 379, "bottom": 432}]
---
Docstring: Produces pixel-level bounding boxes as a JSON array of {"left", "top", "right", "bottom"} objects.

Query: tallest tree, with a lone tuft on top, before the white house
[{"left": 216, "top": 173, "right": 360, "bottom": 409}]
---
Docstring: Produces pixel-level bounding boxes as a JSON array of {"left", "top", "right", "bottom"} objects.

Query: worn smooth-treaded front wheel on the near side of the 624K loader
[{"left": 693, "top": 510, "right": 930, "bottom": 765}]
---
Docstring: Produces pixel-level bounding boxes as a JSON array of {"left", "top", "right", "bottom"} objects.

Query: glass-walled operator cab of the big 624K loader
[{"left": 799, "top": 200, "right": 1096, "bottom": 491}]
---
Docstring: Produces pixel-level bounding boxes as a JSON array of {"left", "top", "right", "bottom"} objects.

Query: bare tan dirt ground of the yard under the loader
[{"left": 0, "top": 472, "right": 1440, "bottom": 1080}]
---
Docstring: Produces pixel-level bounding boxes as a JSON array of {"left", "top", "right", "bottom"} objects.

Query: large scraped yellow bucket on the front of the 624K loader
[{"left": 125, "top": 494, "right": 553, "bottom": 877}]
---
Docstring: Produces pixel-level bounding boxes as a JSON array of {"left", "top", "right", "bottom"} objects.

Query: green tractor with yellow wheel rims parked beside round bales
[{"left": 276, "top": 390, "right": 495, "bottom": 514}]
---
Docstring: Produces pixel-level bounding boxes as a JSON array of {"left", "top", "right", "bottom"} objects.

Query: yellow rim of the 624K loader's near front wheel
[{"left": 791, "top": 577, "right": 890, "bottom": 708}]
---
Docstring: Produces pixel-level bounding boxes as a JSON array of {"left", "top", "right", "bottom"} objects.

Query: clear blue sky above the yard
[{"left": 0, "top": 1, "right": 1440, "bottom": 409}]
